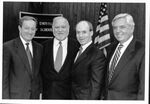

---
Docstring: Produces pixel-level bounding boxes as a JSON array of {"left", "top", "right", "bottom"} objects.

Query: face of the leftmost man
[{"left": 18, "top": 20, "right": 37, "bottom": 42}]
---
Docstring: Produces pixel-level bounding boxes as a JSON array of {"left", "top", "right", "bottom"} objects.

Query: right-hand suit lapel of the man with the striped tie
[{"left": 110, "top": 40, "right": 135, "bottom": 83}]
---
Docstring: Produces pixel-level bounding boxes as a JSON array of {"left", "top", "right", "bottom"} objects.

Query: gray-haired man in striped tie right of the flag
[{"left": 106, "top": 13, "right": 145, "bottom": 100}]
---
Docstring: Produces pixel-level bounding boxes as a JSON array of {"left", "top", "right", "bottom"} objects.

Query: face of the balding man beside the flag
[{"left": 76, "top": 21, "right": 93, "bottom": 46}]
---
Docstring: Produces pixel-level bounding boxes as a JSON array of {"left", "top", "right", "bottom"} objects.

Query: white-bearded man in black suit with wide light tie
[{"left": 41, "top": 17, "right": 79, "bottom": 99}]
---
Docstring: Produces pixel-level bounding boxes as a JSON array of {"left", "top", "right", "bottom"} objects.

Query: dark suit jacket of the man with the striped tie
[{"left": 106, "top": 39, "right": 145, "bottom": 100}]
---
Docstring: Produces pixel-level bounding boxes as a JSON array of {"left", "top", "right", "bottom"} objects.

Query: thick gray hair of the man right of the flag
[{"left": 112, "top": 13, "right": 135, "bottom": 26}]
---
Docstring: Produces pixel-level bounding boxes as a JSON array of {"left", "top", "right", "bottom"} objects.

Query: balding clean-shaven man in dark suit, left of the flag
[{"left": 72, "top": 21, "right": 106, "bottom": 100}]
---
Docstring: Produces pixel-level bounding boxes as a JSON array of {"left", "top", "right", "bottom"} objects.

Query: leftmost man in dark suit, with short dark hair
[{"left": 2, "top": 16, "right": 42, "bottom": 99}]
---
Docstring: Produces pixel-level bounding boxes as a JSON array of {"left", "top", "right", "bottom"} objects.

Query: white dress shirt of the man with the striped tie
[{"left": 109, "top": 36, "right": 133, "bottom": 68}]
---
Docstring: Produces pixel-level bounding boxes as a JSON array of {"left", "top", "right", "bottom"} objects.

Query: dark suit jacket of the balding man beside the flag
[{"left": 72, "top": 44, "right": 106, "bottom": 100}]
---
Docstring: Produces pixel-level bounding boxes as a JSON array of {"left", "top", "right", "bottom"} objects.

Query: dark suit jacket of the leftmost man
[{"left": 2, "top": 38, "right": 42, "bottom": 99}]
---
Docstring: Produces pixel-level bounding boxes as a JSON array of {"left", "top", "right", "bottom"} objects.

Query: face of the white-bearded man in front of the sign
[{"left": 52, "top": 17, "right": 69, "bottom": 41}]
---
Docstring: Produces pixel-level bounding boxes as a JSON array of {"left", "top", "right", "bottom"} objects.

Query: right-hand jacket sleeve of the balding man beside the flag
[{"left": 90, "top": 51, "right": 106, "bottom": 99}]
